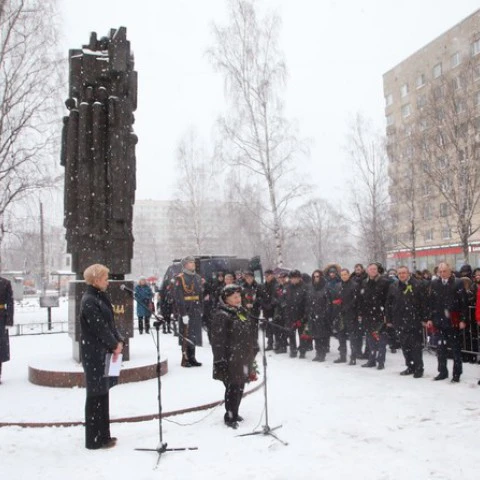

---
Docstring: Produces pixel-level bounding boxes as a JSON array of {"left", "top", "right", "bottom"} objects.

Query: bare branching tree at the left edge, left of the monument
[{"left": 0, "top": 0, "right": 60, "bottom": 270}]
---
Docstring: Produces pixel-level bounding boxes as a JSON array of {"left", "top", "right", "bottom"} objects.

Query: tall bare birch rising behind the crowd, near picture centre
[{"left": 208, "top": 0, "right": 302, "bottom": 266}]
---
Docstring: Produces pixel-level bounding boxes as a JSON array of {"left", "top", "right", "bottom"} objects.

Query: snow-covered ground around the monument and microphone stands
[{"left": 0, "top": 300, "right": 480, "bottom": 480}]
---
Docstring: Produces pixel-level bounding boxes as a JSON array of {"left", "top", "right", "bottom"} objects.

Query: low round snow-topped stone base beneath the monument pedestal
[{"left": 28, "top": 358, "right": 168, "bottom": 388}]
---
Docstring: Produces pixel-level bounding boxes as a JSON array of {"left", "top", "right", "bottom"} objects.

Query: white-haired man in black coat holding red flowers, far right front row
[{"left": 427, "top": 263, "right": 469, "bottom": 382}]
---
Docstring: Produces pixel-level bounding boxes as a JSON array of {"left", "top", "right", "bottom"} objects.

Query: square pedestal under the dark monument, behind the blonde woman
[{"left": 68, "top": 280, "right": 133, "bottom": 362}]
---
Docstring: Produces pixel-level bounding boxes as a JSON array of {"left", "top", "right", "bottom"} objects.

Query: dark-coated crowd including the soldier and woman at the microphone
[{"left": 133, "top": 257, "right": 480, "bottom": 428}]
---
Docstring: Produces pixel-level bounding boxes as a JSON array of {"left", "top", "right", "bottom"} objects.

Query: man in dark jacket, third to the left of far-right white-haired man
[{"left": 336, "top": 268, "right": 362, "bottom": 365}]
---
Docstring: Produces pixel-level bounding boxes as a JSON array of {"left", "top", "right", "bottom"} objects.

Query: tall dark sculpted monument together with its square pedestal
[{"left": 61, "top": 27, "right": 138, "bottom": 360}]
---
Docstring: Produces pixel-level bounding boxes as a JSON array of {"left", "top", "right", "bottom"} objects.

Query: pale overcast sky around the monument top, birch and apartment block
[{"left": 60, "top": 0, "right": 479, "bottom": 203}]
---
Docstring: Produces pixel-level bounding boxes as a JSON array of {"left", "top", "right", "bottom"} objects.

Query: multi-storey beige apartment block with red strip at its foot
[{"left": 383, "top": 10, "right": 480, "bottom": 269}]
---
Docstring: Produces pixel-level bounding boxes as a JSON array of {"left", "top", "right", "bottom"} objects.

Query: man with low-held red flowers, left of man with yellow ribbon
[{"left": 356, "top": 263, "right": 390, "bottom": 370}]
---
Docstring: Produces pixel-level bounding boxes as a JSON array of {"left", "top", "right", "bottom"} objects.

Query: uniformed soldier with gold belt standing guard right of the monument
[{"left": 173, "top": 257, "right": 203, "bottom": 367}]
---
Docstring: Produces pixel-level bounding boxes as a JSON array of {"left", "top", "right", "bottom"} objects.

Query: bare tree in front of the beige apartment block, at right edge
[{"left": 415, "top": 59, "right": 480, "bottom": 262}]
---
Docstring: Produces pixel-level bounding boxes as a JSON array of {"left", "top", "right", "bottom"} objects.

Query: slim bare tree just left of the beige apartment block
[{"left": 348, "top": 115, "right": 389, "bottom": 263}]
